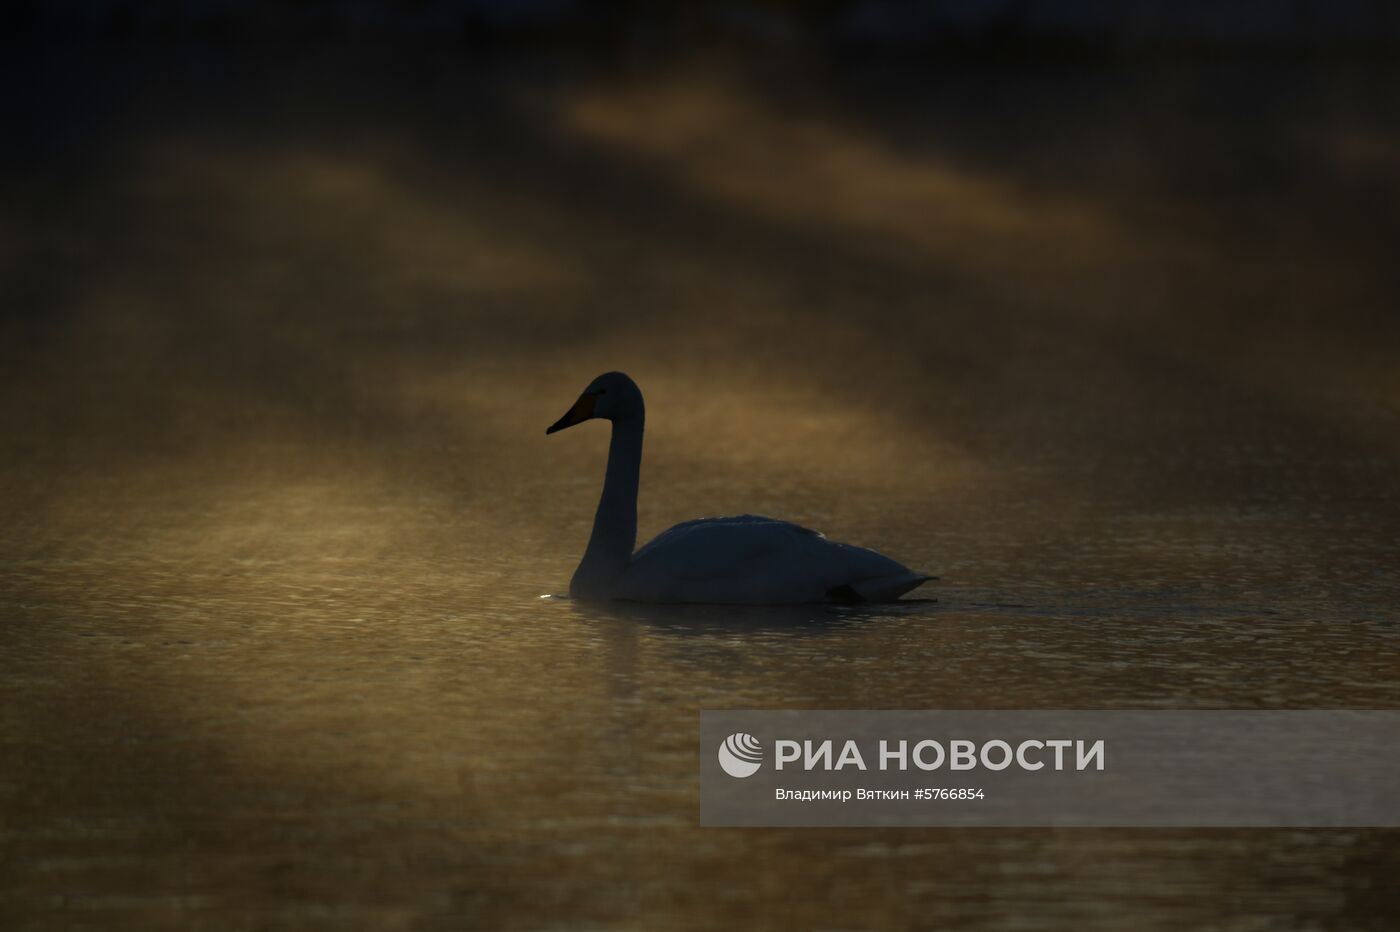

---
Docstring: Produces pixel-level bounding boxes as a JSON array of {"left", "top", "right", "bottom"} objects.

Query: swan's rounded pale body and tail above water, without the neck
[{"left": 615, "top": 515, "right": 930, "bottom": 605}]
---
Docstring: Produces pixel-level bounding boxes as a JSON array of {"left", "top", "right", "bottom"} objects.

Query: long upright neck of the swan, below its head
[{"left": 568, "top": 411, "right": 645, "bottom": 599}]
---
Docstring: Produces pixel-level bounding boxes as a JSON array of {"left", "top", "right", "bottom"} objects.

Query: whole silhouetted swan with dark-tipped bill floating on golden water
[{"left": 545, "top": 372, "right": 934, "bottom": 605}]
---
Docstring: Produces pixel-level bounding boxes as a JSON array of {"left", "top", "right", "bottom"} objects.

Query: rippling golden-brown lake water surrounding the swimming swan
[{"left": 0, "top": 39, "right": 1400, "bottom": 929}]
